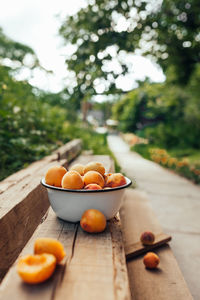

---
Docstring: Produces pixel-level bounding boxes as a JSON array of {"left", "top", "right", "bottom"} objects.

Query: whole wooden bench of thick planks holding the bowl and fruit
[{"left": 0, "top": 141, "right": 192, "bottom": 300}]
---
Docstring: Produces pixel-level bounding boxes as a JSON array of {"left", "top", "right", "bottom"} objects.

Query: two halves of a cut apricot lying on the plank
[{"left": 17, "top": 238, "right": 66, "bottom": 284}]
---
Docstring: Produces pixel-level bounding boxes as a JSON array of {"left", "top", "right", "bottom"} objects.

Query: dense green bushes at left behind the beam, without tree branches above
[{"left": 0, "top": 66, "right": 67, "bottom": 179}]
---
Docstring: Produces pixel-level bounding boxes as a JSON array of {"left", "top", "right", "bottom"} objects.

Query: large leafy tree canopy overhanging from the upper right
[{"left": 60, "top": 0, "right": 200, "bottom": 106}]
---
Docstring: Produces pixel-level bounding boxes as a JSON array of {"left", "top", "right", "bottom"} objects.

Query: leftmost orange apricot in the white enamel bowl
[{"left": 45, "top": 166, "right": 67, "bottom": 187}]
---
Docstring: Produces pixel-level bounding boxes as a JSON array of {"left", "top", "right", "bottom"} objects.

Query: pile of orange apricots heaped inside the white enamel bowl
[{"left": 45, "top": 162, "right": 126, "bottom": 190}]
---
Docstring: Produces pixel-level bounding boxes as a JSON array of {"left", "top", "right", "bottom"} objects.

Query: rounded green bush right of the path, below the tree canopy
[{"left": 113, "top": 79, "right": 200, "bottom": 149}]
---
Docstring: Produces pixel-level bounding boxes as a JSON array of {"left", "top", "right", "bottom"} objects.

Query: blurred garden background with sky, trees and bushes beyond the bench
[{"left": 0, "top": 0, "right": 200, "bottom": 183}]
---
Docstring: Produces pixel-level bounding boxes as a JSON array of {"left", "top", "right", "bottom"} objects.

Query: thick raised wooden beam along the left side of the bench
[{"left": 0, "top": 140, "right": 81, "bottom": 280}]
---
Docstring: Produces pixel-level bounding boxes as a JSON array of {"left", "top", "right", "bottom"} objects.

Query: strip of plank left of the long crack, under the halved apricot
[{"left": 0, "top": 209, "right": 77, "bottom": 300}]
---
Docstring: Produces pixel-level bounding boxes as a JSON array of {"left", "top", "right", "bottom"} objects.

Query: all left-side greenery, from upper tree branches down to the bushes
[{"left": 0, "top": 31, "right": 68, "bottom": 180}]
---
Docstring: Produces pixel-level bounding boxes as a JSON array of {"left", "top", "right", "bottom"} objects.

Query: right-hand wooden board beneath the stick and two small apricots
[{"left": 120, "top": 190, "right": 193, "bottom": 300}]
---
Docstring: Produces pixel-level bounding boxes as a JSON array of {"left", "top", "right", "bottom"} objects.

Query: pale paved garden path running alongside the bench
[{"left": 108, "top": 135, "right": 200, "bottom": 300}]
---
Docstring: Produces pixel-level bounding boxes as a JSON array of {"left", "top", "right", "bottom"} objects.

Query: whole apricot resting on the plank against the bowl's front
[{"left": 80, "top": 209, "right": 106, "bottom": 233}]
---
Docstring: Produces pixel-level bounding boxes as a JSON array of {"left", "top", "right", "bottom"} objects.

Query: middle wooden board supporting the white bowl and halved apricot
[{"left": 0, "top": 156, "right": 130, "bottom": 300}]
